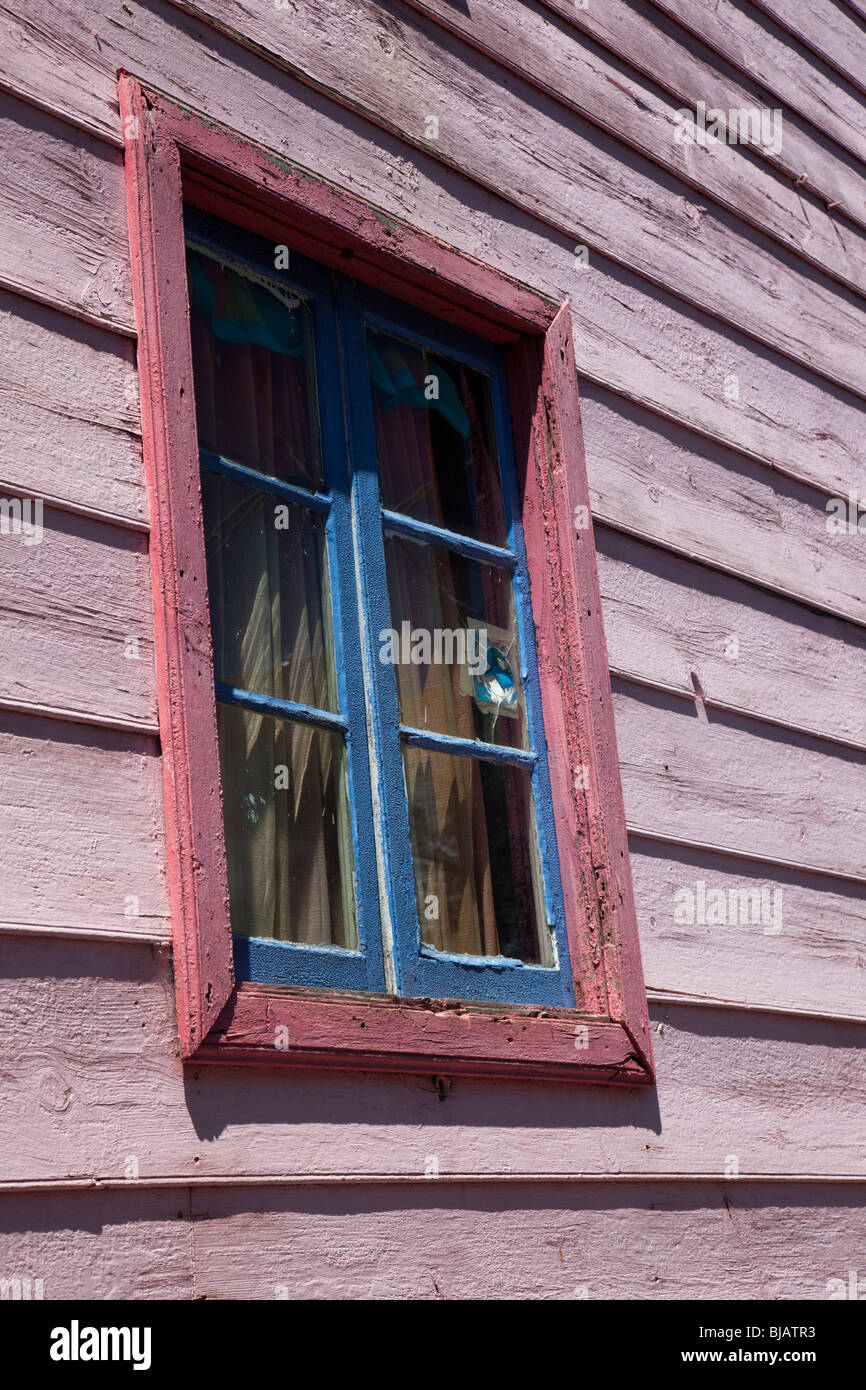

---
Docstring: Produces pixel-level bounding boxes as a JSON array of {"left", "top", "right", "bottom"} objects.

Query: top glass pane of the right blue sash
[{"left": 367, "top": 331, "right": 506, "bottom": 545}]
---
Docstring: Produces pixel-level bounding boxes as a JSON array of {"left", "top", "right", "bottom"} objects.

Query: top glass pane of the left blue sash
[{"left": 186, "top": 247, "right": 321, "bottom": 488}]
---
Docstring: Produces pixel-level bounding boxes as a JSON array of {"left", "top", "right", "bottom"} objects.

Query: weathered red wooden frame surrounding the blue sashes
[{"left": 120, "top": 72, "right": 653, "bottom": 1086}]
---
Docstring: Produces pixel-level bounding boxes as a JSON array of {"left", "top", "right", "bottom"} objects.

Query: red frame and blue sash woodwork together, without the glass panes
[{"left": 121, "top": 76, "right": 652, "bottom": 1084}]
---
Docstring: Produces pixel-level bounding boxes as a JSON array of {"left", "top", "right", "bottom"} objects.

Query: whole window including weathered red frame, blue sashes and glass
[{"left": 121, "top": 70, "right": 652, "bottom": 1084}]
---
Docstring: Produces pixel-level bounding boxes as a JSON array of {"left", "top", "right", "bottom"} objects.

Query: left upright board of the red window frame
[{"left": 118, "top": 76, "right": 235, "bottom": 1056}]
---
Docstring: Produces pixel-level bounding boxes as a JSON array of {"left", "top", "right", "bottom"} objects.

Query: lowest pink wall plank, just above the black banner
[{"left": 0, "top": 1179, "right": 866, "bottom": 1295}]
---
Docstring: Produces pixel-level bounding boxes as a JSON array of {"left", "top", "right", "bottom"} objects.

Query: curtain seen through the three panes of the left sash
[{"left": 188, "top": 252, "right": 356, "bottom": 947}]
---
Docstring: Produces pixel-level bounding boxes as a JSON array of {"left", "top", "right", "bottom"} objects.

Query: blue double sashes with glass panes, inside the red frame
[{"left": 186, "top": 209, "right": 574, "bottom": 1006}]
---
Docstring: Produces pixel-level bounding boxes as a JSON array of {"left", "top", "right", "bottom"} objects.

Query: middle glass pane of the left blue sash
[{"left": 202, "top": 470, "right": 336, "bottom": 710}]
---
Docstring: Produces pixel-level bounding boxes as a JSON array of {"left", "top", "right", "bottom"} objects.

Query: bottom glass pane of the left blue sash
[{"left": 217, "top": 703, "right": 357, "bottom": 949}]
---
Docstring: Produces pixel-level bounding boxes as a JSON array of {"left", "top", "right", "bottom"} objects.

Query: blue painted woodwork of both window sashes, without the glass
[{"left": 185, "top": 209, "right": 574, "bottom": 1008}]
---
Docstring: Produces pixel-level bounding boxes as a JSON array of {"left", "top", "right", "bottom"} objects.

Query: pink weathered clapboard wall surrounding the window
[{"left": 0, "top": 0, "right": 866, "bottom": 1298}]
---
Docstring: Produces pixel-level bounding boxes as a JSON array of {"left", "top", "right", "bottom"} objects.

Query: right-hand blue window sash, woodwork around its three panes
[{"left": 336, "top": 279, "right": 574, "bottom": 1008}]
